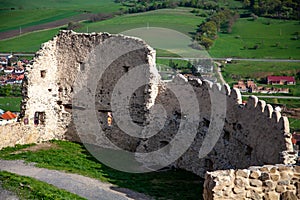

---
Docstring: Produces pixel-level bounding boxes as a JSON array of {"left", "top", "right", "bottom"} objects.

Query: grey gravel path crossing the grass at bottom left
[{"left": 0, "top": 160, "right": 152, "bottom": 200}]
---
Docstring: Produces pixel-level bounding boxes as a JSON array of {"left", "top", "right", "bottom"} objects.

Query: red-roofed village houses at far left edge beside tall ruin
[{"left": 0, "top": 56, "right": 30, "bottom": 85}]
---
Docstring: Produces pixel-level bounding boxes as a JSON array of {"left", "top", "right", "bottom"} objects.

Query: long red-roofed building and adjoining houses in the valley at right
[{"left": 233, "top": 76, "right": 296, "bottom": 94}]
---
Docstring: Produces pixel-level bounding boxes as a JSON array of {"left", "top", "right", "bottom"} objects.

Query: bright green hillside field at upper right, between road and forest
[{"left": 209, "top": 18, "right": 300, "bottom": 59}]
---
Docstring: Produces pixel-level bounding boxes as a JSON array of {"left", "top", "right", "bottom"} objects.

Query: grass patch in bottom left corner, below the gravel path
[{"left": 0, "top": 171, "right": 84, "bottom": 200}]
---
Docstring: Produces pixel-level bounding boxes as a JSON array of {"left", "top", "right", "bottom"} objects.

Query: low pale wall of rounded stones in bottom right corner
[{"left": 203, "top": 165, "right": 300, "bottom": 200}]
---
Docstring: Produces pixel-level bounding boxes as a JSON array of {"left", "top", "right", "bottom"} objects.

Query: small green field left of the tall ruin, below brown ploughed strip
[{"left": 0, "top": 28, "right": 60, "bottom": 53}]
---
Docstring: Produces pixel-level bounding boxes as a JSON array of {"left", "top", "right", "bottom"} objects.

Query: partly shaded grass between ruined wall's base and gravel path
[{"left": 0, "top": 141, "right": 203, "bottom": 199}]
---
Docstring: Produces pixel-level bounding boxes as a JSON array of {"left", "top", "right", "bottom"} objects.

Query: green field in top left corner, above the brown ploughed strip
[{"left": 0, "top": 0, "right": 121, "bottom": 32}]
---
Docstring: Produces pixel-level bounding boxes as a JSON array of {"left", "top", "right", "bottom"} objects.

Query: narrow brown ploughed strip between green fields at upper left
[{"left": 0, "top": 14, "right": 91, "bottom": 40}]
